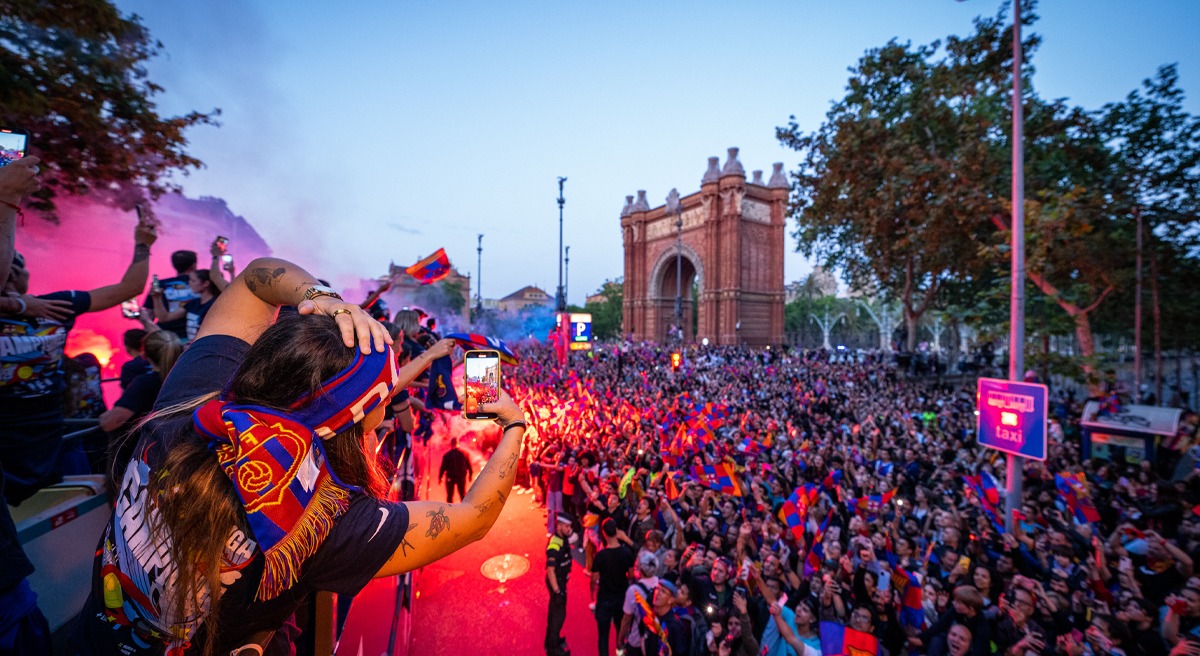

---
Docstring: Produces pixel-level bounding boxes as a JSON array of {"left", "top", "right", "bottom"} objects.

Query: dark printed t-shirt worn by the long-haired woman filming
[{"left": 72, "top": 335, "right": 409, "bottom": 656}]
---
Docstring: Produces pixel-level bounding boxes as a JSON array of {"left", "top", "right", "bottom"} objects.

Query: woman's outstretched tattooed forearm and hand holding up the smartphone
[{"left": 376, "top": 391, "right": 524, "bottom": 578}]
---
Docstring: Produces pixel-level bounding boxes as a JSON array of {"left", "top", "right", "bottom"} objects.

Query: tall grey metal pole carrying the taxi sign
[{"left": 1004, "top": 0, "right": 1025, "bottom": 531}]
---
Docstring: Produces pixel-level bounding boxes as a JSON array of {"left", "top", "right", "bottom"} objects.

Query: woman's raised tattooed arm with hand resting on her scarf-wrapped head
[{"left": 196, "top": 258, "right": 391, "bottom": 353}]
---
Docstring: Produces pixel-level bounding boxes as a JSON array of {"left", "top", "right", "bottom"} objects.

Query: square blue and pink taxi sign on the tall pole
[{"left": 976, "top": 378, "right": 1048, "bottom": 461}]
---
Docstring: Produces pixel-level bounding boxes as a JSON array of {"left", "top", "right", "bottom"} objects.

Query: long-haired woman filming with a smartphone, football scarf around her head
[{"left": 72, "top": 259, "right": 524, "bottom": 655}]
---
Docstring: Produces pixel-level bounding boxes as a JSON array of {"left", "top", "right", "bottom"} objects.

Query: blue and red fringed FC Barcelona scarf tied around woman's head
[{"left": 192, "top": 348, "right": 400, "bottom": 601}]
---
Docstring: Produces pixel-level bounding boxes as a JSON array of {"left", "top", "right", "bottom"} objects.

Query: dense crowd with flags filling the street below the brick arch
[{"left": 514, "top": 344, "right": 1200, "bottom": 656}]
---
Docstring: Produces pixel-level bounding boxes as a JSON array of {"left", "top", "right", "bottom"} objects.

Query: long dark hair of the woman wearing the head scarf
[{"left": 148, "top": 314, "right": 386, "bottom": 655}]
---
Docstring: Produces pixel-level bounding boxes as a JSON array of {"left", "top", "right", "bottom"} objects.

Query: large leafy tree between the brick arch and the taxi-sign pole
[{"left": 776, "top": 23, "right": 1012, "bottom": 349}]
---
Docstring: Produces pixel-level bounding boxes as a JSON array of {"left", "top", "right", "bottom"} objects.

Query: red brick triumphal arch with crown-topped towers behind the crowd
[{"left": 620, "top": 148, "right": 788, "bottom": 345}]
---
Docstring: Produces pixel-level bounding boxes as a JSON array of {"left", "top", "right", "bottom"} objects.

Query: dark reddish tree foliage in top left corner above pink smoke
[{"left": 0, "top": 0, "right": 220, "bottom": 218}]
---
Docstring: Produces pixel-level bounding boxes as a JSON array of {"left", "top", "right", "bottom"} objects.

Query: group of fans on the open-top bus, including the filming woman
[{"left": 0, "top": 157, "right": 526, "bottom": 656}]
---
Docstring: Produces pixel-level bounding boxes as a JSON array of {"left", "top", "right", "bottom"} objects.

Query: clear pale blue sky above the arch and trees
[{"left": 118, "top": 0, "right": 1200, "bottom": 303}]
